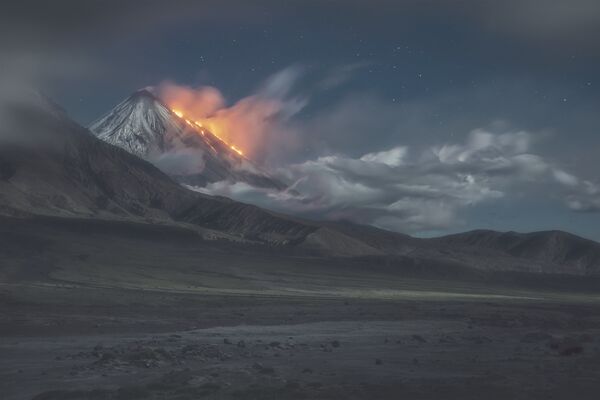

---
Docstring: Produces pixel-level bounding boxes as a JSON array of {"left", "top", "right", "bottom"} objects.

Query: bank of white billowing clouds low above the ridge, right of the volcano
[{"left": 191, "top": 129, "right": 600, "bottom": 233}]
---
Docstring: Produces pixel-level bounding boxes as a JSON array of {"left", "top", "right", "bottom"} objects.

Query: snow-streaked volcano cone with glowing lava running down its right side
[{"left": 89, "top": 89, "right": 286, "bottom": 190}]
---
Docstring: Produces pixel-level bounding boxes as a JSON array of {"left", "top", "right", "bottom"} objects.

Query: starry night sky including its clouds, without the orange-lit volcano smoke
[{"left": 0, "top": 0, "right": 600, "bottom": 240}]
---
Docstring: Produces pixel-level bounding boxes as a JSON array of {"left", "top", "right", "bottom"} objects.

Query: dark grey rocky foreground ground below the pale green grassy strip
[{"left": 0, "top": 287, "right": 600, "bottom": 400}]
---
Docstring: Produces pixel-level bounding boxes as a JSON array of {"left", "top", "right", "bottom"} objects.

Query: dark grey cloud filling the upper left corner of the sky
[{"left": 0, "top": 0, "right": 284, "bottom": 88}]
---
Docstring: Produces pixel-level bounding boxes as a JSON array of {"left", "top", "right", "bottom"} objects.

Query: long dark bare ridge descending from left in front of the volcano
[{"left": 0, "top": 94, "right": 600, "bottom": 275}]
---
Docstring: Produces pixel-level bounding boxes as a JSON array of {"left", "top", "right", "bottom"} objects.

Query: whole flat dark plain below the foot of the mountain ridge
[{"left": 0, "top": 219, "right": 600, "bottom": 400}]
